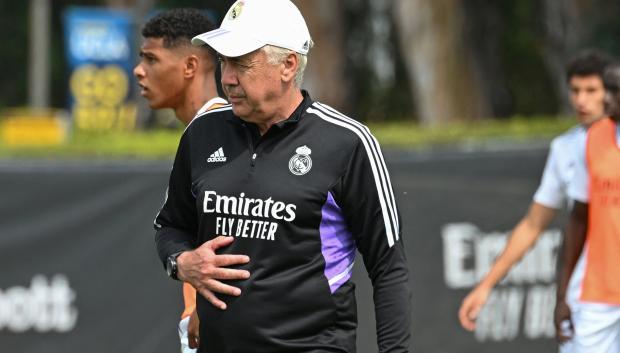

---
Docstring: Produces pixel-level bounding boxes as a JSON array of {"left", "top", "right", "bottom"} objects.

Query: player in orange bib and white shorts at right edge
[{"left": 555, "top": 63, "right": 620, "bottom": 353}]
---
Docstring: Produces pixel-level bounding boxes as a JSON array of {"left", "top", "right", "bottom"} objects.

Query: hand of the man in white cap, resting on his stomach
[{"left": 177, "top": 236, "right": 250, "bottom": 310}]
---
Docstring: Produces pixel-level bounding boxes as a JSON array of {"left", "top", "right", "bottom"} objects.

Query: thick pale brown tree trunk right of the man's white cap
[{"left": 394, "top": 0, "right": 489, "bottom": 124}]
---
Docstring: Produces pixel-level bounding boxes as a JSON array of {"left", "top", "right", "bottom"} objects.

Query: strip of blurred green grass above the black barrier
[{"left": 0, "top": 117, "right": 575, "bottom": 159}]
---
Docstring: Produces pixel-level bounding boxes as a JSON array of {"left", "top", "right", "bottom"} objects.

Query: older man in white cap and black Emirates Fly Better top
[{"left": 156, "top": 0, "right": 410, "bottom": 353}]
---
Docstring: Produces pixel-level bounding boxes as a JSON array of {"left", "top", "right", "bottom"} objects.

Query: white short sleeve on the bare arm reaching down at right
[{"left": 534, "top": 139, "right": 566, "bottom": 209}]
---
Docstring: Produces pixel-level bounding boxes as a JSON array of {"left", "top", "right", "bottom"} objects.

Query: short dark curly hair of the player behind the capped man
[{"left": 142, "top": 8, "right": 215, "bottom": 48}]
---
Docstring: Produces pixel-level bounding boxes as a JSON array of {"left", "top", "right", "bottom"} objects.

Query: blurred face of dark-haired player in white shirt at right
[{"left": 568, "top": 75, "right": 605, "bottom": 124}]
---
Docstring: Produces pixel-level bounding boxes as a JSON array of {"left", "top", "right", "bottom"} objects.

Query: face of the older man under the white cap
[{"left": 220, "top": 49, "right": 283, "bottom": 123}]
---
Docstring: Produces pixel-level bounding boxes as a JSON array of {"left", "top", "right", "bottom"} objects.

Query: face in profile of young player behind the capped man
[{"left": 133, "top": 38, "right": 185, "bottom": 109}]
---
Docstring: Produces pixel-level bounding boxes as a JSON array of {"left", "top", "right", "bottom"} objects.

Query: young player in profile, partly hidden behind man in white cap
[{"left": 133, "top": 9, "right": 227, "bottom": 352}]
